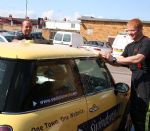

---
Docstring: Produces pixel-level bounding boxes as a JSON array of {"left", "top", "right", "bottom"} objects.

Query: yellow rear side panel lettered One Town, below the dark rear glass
[{"left": 0, "top": 98, "right": 87, "bottom": 131}]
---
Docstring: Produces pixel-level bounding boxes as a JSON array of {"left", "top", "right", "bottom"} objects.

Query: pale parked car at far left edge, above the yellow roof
[{"left": 0, "top": 33, "right": 15, "bottom": 42}]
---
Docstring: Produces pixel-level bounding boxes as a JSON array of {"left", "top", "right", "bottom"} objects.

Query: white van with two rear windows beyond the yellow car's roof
[{"left": 53, "top": 31, "right": 84, "bottom": 48}]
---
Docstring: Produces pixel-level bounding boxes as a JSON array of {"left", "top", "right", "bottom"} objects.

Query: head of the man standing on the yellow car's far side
[{"left": 21, "top": 20, "right": 32, "bottom": 36}]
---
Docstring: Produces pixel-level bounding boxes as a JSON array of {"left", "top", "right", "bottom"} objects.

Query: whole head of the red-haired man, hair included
[{"left": 127, "top": 18, "right": 143, "bottom": 41}]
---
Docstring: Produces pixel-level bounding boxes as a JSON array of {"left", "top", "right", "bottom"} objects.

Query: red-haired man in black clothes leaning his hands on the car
[{"left": 100, "top": 18, "right": 150, "bottom": 131}]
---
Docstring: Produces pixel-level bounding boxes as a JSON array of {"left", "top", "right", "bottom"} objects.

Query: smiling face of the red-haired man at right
[{"left": 127, "top": 25, "right": 142, "bottom": 41}]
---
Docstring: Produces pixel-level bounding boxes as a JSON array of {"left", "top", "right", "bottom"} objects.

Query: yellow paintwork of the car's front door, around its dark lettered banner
[{"left": 86, "top": 89, "right": 128, "bottom": 131}]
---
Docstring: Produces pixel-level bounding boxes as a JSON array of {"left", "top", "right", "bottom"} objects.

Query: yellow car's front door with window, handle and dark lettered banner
[{"left": 76, "top": 58, "right": 126, "bottom": 131}]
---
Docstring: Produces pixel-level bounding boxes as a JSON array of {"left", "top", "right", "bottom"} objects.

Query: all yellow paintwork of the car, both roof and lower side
[{"left": 0, "top": 41, "right": 127, "bottom": 131}]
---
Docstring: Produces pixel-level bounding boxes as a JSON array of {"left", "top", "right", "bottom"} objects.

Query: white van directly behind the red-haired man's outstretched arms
[{"left": 112, "top": 32, "right": 133, "bottom": 57}]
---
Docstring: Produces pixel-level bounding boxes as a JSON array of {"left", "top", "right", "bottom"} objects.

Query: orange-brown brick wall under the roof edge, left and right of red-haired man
[{"left": 80, "top": 20, "right": 150, "bottom": 41}]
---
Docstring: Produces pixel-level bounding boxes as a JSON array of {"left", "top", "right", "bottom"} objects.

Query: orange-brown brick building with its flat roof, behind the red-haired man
[{"left": 78, "top": 16, "right": 150, "bottom": 41}]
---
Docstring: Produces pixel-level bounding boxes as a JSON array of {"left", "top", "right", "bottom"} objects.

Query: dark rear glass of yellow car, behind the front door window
[{"left": 0, "top": 59, "right": 82, "bottom": 112}]
